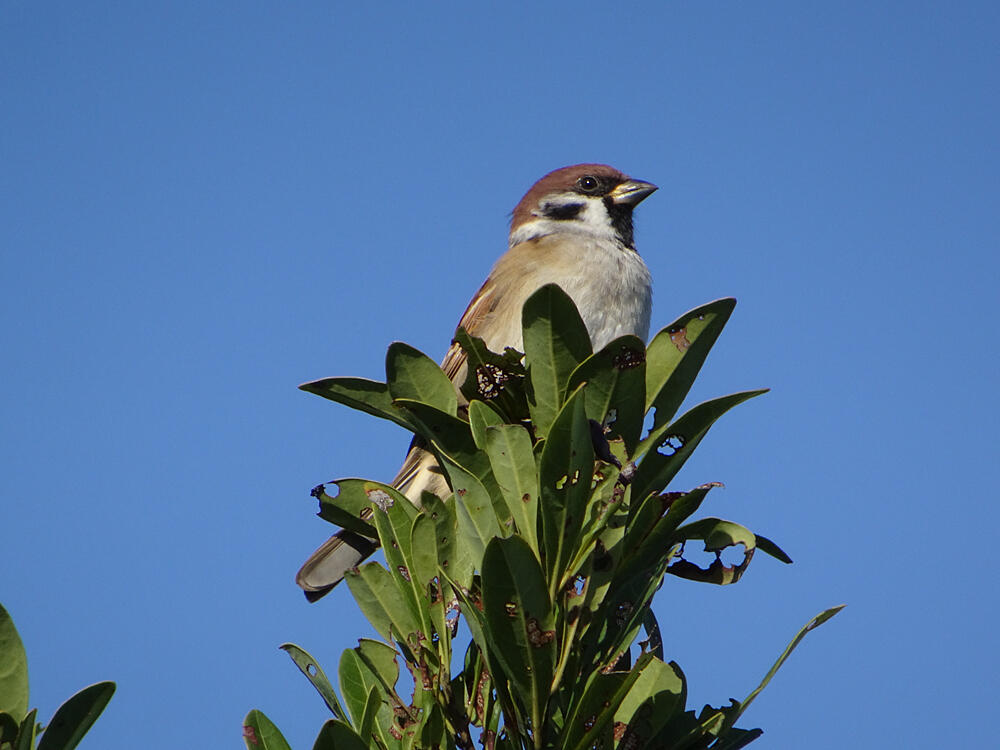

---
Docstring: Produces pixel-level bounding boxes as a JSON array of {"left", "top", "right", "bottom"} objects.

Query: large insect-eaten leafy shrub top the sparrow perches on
[{"left": 254, "top": 286, "right": 839, "bottom": 750}]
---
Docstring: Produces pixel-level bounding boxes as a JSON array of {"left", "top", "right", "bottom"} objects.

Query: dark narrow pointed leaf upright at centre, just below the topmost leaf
[{"left": 539, "top": 389, "right": 594, "bottom": 597}]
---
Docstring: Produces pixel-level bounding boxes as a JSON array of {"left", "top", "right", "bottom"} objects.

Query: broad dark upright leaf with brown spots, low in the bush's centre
[{"left": 482, "top": 536, "right": 556, "bottom": 727}]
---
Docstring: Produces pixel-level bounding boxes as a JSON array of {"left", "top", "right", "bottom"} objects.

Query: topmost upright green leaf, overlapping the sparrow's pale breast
[{"left": 521, "top": 284, "right": 593, "bottom": 437}]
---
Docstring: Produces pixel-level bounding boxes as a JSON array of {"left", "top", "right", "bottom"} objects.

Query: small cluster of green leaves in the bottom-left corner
[{"left": 0, "top": 606, "right": 115, "bottom": 750}]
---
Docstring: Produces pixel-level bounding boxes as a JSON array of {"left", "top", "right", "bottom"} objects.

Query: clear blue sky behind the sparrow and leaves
[{"left": 0, "top": 0, "right": 1000, "bottom": 750}]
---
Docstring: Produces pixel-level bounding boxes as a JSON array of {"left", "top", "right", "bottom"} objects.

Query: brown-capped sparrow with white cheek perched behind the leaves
[{"left": 295, "top": 164, "right": 657, "bottom": 601}]
